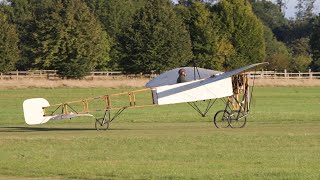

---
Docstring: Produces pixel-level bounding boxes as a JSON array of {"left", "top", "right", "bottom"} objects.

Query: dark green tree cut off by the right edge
[{"left": 310, "top": 14, "right": 320, "bottom": 72}]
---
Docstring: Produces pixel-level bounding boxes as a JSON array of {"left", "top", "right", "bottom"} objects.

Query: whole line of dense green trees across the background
[{"left": 0, "top": 0, "right": 320, "bottom": 78}]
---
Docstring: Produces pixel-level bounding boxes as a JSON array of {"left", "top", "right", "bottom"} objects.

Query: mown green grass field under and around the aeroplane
[{"left": 0, "top": 87, "right": 320, "bottom": 179}]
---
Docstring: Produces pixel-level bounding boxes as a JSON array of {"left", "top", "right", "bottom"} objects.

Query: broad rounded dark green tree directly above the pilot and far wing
[{"left": 120, "top": 0, "right": 192, "bottom": 73}]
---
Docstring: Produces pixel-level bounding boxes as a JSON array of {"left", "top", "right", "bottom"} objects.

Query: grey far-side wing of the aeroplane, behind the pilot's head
[{"left": 146, "top": 67, "right": 222, "bottom": 88}]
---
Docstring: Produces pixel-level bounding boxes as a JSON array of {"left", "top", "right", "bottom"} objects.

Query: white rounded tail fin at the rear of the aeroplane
[{"left": 23, "top": 98, "right": 51, "bottom": 125}]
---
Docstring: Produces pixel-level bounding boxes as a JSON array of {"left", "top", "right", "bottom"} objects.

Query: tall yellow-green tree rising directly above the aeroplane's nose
[{"left": 213, "top": 0, "right": 265, "bottom": 68}]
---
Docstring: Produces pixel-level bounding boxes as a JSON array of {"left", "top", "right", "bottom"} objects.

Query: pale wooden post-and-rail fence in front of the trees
[{"left": 0, "top": 70, "right": 320, "bottom": 80}]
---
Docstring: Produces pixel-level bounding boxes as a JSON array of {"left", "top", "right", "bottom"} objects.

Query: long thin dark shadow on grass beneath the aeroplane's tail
[{"left": 0, "top": 126, "right": 132, "bottom": 132}]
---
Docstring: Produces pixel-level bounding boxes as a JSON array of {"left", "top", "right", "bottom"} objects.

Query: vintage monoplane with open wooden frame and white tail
[{"left": 23, "top": 63, "right": 266, "bottom": 130}]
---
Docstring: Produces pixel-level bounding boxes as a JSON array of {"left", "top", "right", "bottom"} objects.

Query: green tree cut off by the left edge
[{"left": 0, "top": 11, "right": 19, "bottom": 73}]
